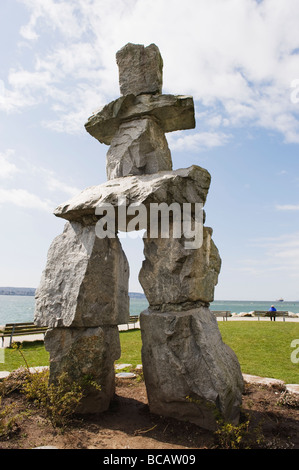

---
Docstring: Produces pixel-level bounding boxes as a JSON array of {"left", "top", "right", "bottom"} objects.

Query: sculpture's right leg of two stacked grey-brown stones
[{"left": 139, "top": 227, "right": 243, "bottom": 430}]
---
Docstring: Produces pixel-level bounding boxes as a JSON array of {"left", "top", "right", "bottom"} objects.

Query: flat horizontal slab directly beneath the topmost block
[{"left": 85, "top": 94, "right": 195, "bottom": 145}]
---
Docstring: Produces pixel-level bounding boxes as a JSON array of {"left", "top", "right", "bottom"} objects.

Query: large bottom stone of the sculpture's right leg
[{"left": 140, "top": 307, "right": 243, "bottom": 430}]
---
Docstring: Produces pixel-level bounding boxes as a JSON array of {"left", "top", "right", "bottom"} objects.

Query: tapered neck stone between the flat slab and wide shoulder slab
[{"left": 107, "top": 118, "right": 172, "bottom": 180}]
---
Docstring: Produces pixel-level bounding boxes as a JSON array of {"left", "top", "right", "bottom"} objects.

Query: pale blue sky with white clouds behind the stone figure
[{"left": 0, "top": 0, "right": 299, "bottom": 301}]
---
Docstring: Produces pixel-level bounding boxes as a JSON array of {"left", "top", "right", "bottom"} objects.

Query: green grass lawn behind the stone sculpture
[{"left": 0, "top": 321, "right": 299, "bottom": 383}]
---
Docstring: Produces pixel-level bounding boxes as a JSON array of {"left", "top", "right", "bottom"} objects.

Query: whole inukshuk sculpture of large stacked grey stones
[{"left": 35, "top": 44, "right": 243, "bottom": 429}]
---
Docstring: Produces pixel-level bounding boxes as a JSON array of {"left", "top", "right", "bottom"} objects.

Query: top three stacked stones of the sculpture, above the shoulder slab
[{"left": 85, "top": 43, "right": 195, "bottom": 180}]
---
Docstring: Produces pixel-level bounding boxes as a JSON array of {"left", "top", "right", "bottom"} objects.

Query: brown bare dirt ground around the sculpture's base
[{"left": 0, "top": 379, "right": 299, "bottom": 450}]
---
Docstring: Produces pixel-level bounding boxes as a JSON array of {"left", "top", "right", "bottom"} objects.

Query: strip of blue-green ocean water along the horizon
[{"left": 0, "top": 295, "right": 299, "bottom": 325}]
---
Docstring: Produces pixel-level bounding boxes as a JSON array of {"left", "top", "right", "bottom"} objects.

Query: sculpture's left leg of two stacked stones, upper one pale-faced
[{"left": 35, "top": 222, "right": 129, "bottom": 413}]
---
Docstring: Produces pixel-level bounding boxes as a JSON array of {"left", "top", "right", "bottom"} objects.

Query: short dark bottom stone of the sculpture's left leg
[{"left": 45, "top": 326, "right": 121, "bottom": 413}]
